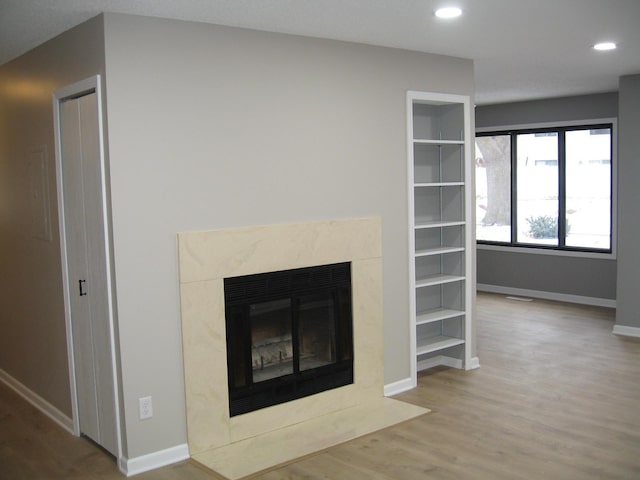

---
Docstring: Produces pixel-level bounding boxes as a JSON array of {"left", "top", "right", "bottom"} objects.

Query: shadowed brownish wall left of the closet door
[{"left": 0, "top": 18, "right": 104, "bottom": 417}]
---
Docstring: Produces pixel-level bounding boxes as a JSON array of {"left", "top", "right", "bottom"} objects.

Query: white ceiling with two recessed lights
[{"left": 0, "top": 0, "right": 640, "bottom": 104}]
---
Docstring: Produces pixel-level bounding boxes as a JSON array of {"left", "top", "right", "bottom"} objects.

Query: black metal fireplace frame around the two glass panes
[{"left": 224, "top": 262, "right": 353, "bottom": 417}]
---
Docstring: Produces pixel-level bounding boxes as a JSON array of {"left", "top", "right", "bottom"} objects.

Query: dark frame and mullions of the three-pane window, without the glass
[{"left": 475, "top": 121, "right": 617, "bottom": 254}]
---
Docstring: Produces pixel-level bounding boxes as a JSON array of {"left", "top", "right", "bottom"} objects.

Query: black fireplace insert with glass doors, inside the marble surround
[{"left": 224, "top": 262, "right": 353, "bottom": 416}]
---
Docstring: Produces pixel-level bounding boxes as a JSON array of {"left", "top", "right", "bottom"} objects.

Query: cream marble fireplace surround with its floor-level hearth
[{"left": 178, "top": 217, "right": 428, "bottom": 479}]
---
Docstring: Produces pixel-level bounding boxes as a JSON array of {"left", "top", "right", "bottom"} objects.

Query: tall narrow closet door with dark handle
[{"left": 60, "top": 93, "right": 117, "bottom": 455}]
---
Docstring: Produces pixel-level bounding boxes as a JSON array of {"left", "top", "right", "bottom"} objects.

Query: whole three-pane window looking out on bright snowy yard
[{"left": 476, "top": 124, "right": 613, "bottom": 252}]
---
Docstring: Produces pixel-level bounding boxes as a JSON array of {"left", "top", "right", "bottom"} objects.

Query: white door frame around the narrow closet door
[{"left": 53, "top": 75, "right": 123, "bottom": 464}]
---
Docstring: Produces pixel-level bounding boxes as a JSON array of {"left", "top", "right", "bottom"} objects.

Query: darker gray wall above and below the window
[{"left": 476, "top": 93, "right": 618, "bottom": 300}]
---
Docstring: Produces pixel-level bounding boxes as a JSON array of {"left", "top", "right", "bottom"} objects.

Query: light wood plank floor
[{"left": 0, "top": 294, "right": 640, "bottom": 480}]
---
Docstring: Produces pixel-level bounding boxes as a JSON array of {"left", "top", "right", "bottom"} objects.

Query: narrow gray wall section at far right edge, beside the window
[{"left": 616, "top": 75, "right": 640, "bottom": 328}]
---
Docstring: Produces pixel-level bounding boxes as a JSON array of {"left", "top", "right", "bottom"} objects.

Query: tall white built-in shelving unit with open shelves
[{"left": 407, "top": 92, "right": 478, "bottom": 382}]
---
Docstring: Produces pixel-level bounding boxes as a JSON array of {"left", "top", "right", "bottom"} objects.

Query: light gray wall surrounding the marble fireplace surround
[{"left": 105, "top": 14, "right": 473, "bottom": 457}]
